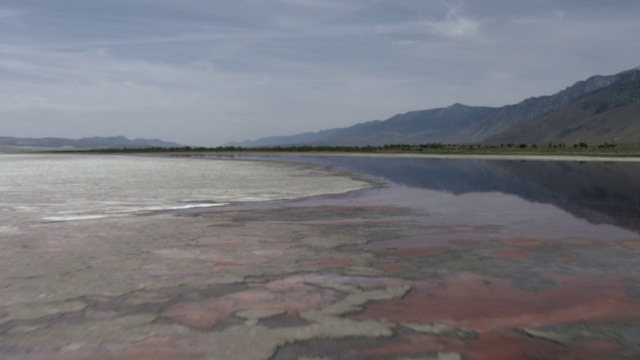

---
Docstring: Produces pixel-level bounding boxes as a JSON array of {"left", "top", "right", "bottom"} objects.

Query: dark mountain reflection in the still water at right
[{"left": 288, "top": 157, "right": 640, "bottom": 232}]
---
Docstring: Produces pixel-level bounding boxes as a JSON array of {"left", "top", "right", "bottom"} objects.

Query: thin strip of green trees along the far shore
[{"left": 58, "top": 142, "right": 640, "bottom": 157}]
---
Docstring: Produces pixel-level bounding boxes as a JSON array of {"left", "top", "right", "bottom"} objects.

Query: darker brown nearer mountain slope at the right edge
[{"left": 486, "top": 70, "right": 640, "bottom": 143}]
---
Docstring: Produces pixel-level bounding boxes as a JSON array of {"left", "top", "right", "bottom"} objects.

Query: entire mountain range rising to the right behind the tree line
[{"left": 227, "top": 67, "right": 640, "bottom": 147}]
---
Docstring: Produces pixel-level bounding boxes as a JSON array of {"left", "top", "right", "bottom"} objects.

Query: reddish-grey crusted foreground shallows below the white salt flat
[{"left": 0, "top": 160, "right": 640, "bottom": 360}]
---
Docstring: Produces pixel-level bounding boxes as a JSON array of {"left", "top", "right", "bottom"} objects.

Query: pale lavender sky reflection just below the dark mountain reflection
[{"left": 330, "top": 185, "right": 640, "bottom": 243}]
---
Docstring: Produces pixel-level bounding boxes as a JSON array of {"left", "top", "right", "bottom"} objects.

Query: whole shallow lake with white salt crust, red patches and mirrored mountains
[{"left": 0, "top": 155, "right": 640, "bottom": 360}]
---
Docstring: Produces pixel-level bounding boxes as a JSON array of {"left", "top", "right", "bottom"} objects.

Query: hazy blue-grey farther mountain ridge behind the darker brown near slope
[{"left": 228, "top": 68, "right": 640, "bottom": 147}]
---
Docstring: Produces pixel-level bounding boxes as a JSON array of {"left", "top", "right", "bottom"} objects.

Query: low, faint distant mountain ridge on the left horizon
[{"left": 0, "top": 136, "right": 183, "bottom": 149}]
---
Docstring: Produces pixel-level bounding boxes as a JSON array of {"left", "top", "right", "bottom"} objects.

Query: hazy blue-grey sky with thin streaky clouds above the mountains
[{"left": 0, "top": 0, "right": 640, "bottom": 146}]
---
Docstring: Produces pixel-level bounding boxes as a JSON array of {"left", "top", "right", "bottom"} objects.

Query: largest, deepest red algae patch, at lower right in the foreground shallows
[{"left": 358, "top": 274, "right": 640, "bottom": 333}]
